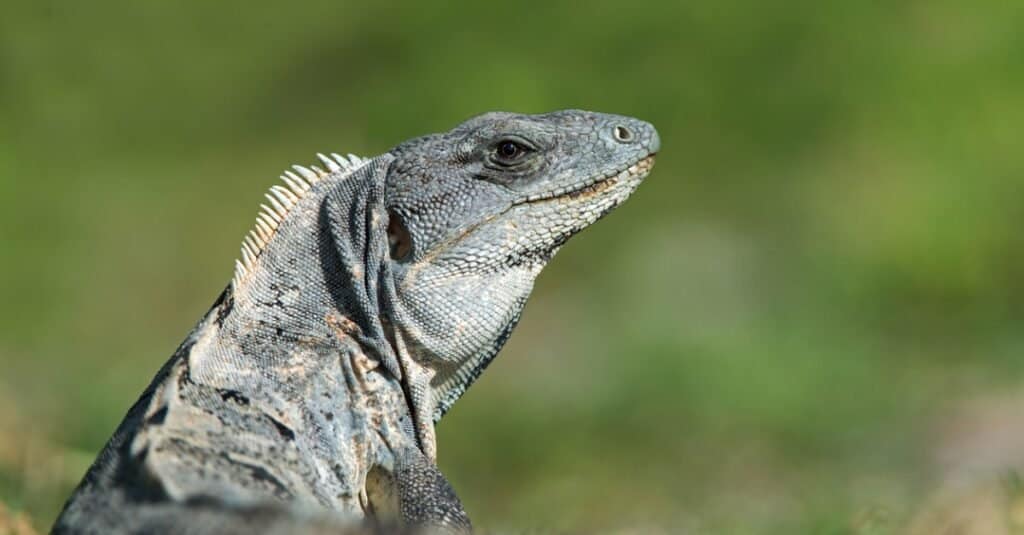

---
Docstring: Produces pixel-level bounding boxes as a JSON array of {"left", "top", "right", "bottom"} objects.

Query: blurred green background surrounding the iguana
[{"left": 0, "top": 0, "right": 1024, "bottom": 534}]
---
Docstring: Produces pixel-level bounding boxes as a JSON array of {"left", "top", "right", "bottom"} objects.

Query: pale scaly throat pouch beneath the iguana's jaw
[{"left": 384, "top": 194, "right": 544, "bottom": 418}]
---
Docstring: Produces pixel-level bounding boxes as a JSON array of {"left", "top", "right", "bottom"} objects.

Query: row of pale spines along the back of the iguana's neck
[{"left": 231, "top": 153, "right": 367, "bottom": 291}]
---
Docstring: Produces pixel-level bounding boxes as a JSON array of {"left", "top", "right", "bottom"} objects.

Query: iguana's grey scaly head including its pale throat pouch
[{"left": 385, "top": 111, "right": 660, "bottom": 419}]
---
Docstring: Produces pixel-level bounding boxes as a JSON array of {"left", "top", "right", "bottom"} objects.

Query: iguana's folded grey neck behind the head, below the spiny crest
[{"left": 201, "top": 155, "right": 399, "bottom": 377}]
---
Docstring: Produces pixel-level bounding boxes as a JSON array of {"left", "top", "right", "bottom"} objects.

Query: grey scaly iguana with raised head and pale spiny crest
[{"left": 54, "top": 111, "right": 660, "bottom": 533}]
